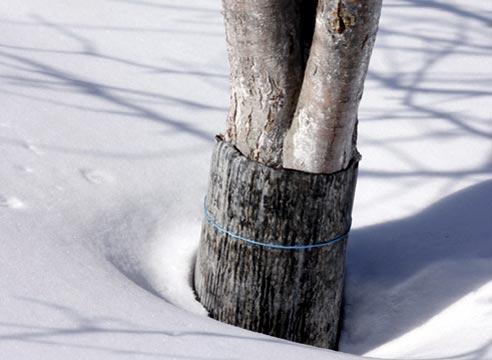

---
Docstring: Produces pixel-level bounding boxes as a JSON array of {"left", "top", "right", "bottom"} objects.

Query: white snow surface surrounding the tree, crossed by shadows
[{"left": 0, "top": 0, "right": 492, "bottom": 360}]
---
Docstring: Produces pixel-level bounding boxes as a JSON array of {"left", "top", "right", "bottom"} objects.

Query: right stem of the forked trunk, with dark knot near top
[{"left": 283, "top": 0, "right": 381, "bottom": 173}]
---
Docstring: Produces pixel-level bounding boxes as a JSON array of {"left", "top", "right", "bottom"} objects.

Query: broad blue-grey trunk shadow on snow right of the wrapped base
[{"left": 344, "top": 180, "right": 492, "bottom": 359}]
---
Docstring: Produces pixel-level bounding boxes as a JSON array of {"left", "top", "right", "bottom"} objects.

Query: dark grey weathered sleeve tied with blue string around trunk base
[{"left": 194, "top": 139, "right": 359, "bottom": 348}]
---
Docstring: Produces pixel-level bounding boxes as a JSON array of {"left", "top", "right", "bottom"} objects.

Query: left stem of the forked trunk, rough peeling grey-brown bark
[{"left": 223, "top": 0, "right": 306, "bottom": 167}]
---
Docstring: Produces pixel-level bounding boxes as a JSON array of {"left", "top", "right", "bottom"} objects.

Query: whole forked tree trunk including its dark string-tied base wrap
[{"left": 194, "top": 0, "right": 381, "bottom": 348}]
